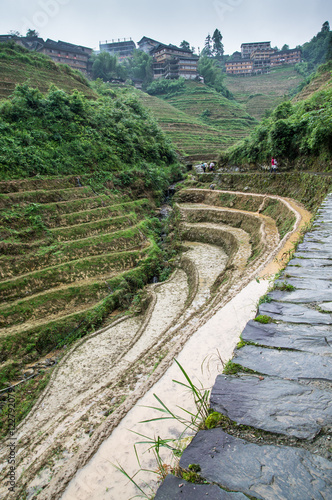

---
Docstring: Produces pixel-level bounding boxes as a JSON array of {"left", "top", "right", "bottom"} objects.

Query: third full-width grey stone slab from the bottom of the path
[{"left": 233, "top": 345, "right": 332, "bottom": 381}]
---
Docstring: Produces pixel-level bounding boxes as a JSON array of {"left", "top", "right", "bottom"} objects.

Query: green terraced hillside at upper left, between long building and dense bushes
[{"left": 0, "top": 43, "right": 96, "bottom": 99}]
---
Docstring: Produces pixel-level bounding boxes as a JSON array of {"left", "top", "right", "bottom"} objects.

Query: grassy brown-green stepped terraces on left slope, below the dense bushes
[{"left": 0, "top": 177, "right": 161, "bottom": 396}]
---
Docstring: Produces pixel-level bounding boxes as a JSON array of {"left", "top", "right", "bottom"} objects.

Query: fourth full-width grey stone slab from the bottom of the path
[{"left": 241, "top": 320, "right": 332, "bottom": 355}]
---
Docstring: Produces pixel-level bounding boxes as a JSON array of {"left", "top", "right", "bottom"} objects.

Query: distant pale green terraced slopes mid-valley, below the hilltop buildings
[{"left": 121, "top": 67, "right": 303, "bottom": 159}]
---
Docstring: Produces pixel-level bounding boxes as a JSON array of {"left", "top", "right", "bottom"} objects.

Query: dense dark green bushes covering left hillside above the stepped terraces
[{"left": 0, "top": 85, "right": 175, "bottom": 181}]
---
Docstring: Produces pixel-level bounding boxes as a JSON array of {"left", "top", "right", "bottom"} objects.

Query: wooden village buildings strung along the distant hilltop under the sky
[{"left": 0, "top": 35, "right": 302, "bottom": 80}]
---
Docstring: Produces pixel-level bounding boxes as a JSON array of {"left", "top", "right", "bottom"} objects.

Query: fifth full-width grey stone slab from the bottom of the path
[{"left": 258, "top": 301, "right": 332, "bottom": 325}]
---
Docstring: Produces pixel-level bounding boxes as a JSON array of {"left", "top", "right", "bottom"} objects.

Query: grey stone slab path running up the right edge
[{"left": 155, "top": 194, "right": 332, "bottom": 500}]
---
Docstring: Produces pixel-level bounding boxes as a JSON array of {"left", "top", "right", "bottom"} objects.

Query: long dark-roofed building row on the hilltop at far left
[{"left": 0, "top": 35, "right": 92, "bottom": 75}]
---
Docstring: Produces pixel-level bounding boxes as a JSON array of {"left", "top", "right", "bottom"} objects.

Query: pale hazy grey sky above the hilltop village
[{"left": 0, "top": 0, "right": 332, "bottom": 54}]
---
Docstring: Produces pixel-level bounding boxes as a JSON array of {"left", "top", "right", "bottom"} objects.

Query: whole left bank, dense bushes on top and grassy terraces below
[{"left": 0, "top": 76, "right": 181, "bottom": 436}]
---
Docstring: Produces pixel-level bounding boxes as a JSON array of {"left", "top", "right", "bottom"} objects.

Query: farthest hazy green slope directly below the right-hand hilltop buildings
[{"left": 225, "top": 66, "right": 303, "bottom": 120}]
